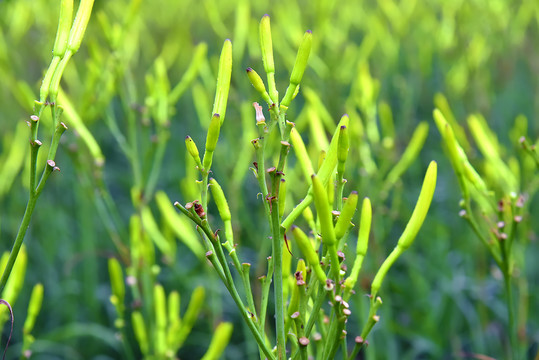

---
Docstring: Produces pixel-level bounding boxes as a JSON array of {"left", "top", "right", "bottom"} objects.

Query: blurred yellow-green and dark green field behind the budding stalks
[{"left": 0, "top": 0, "right": 539, "bottom": 359}]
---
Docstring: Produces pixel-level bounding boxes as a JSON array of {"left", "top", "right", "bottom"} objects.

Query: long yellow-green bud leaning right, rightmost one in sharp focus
[{"left": 398, "top": 161, "right": 437, "bottom": 250}]
